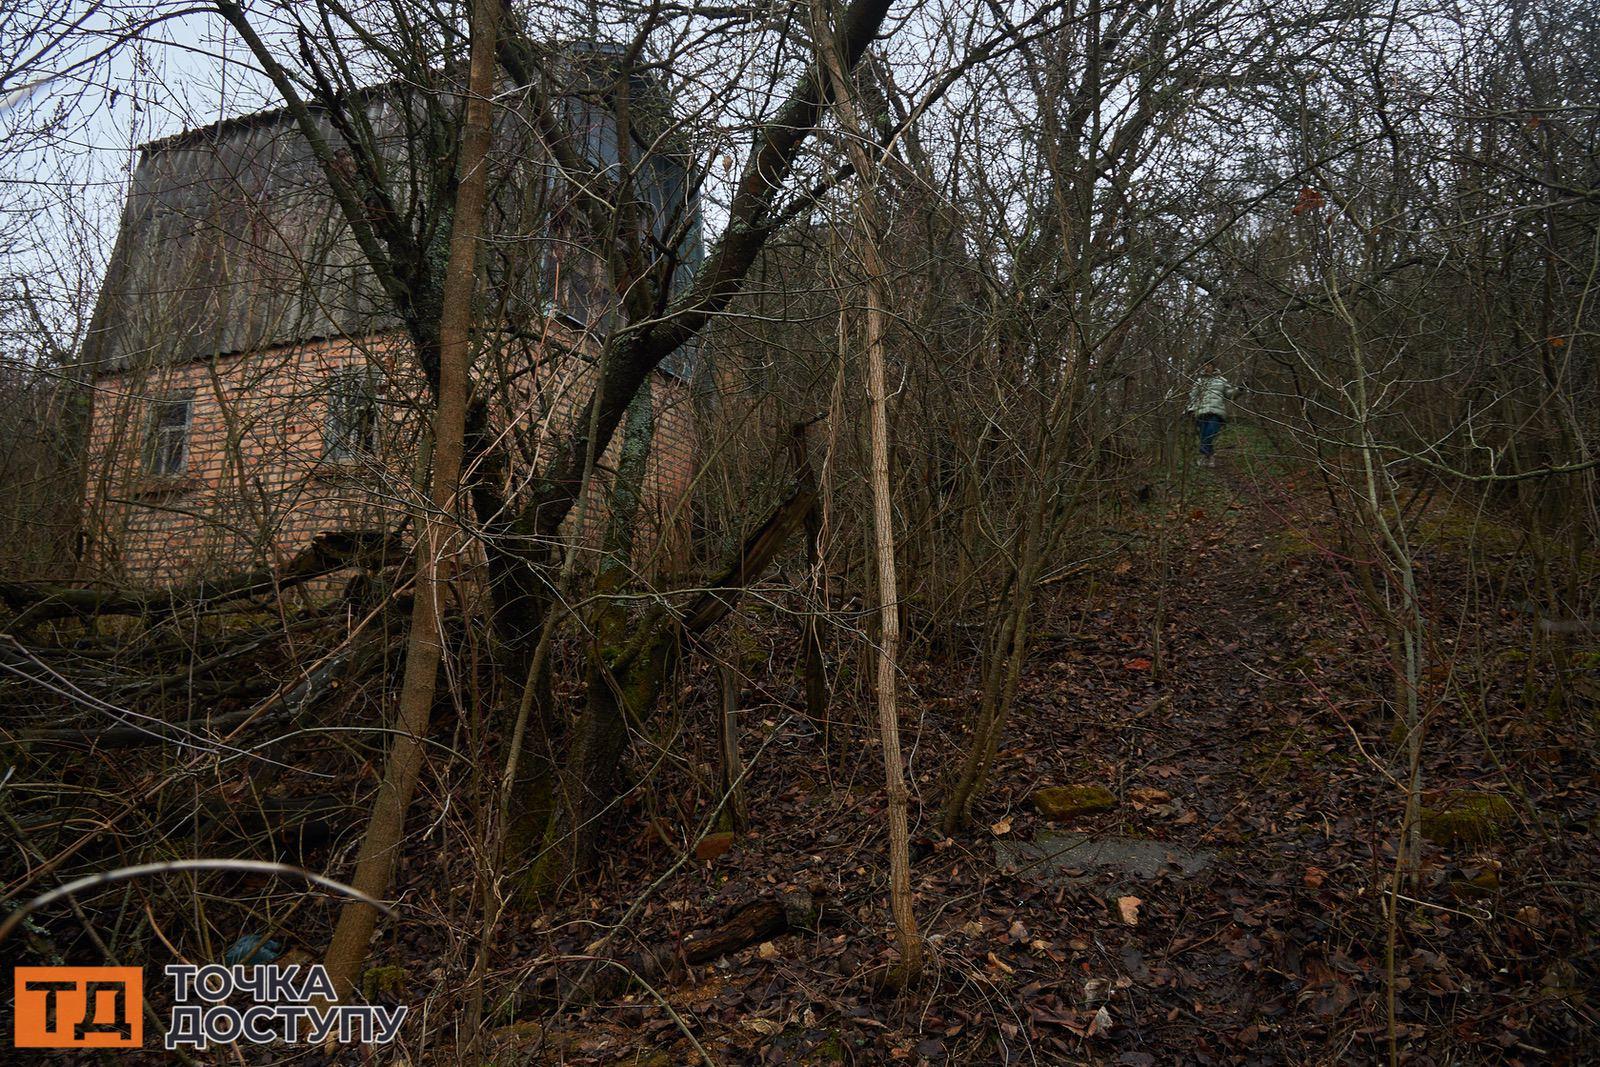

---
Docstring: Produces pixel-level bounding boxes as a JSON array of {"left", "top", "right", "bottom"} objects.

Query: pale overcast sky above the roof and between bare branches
[{"left": 0, "top": 0, "right": 1388, "bottom": 363}]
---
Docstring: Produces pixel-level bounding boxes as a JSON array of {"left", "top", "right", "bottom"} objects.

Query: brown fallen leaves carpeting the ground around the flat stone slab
[{"left": 508, "top": 472, "right": 1600, "bottom": 1067}]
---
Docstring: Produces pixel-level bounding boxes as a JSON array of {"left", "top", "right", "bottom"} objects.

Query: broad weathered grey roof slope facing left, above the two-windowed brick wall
[{"left": 85, "top": 95, "right": 406, "bottom": 373}]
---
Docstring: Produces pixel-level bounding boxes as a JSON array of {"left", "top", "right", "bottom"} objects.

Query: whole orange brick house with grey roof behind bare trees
[{"left": 83, "top": 71, "right": 701, "bottom": 584}]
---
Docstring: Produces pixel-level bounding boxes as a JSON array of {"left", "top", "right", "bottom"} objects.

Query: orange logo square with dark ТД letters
[{"left": 13, "top": 966, "right": 144, "bottom": 1048}]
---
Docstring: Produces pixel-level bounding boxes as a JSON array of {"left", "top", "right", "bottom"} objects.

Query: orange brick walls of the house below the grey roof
[{"left": 85, "top": 338, "right": 696, "bottom": 585}]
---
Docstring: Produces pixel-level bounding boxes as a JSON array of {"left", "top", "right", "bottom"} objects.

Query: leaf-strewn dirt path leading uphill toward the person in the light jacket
[{"left": 979, "top": 447, "right": 1408, "bottom": 1064}]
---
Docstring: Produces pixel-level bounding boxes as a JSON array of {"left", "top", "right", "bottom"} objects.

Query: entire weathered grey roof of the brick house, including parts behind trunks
[{"left": 83, "top": 58, "right": 698, "bottom": 374}]
